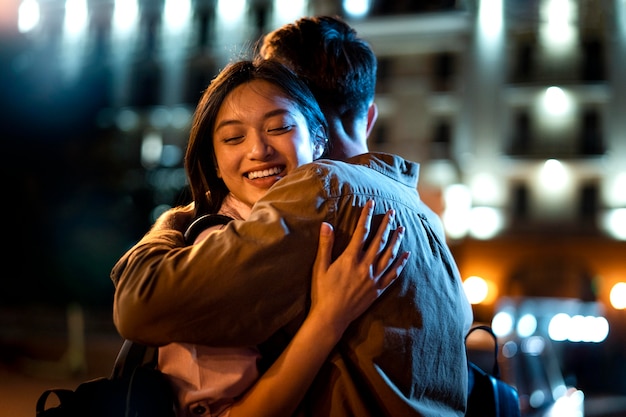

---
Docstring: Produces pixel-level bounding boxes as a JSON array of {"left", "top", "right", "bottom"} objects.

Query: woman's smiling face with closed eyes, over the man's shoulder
[{"left": 213, "top": 80, "right": 319, "bottom": 206}]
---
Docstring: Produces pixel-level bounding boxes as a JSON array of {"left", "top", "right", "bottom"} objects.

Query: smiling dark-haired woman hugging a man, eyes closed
[{"left": 159, "top": 61, "right": 408, "bottom": 417}]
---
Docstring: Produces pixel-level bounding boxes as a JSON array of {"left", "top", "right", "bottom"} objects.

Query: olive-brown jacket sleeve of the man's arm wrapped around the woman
[{"left": 111, "top": 166, "right": 332, "bottom": 346}]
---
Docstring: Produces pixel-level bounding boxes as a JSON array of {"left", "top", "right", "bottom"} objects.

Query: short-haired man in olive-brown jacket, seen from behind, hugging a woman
[{"left": 111, "top": 17, "right": 472, "bottom": 417}]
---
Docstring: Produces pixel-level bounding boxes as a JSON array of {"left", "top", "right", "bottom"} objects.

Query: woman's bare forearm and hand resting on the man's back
[{"left": 230, "top": 201, "right": 409, "bottom": 417}]
